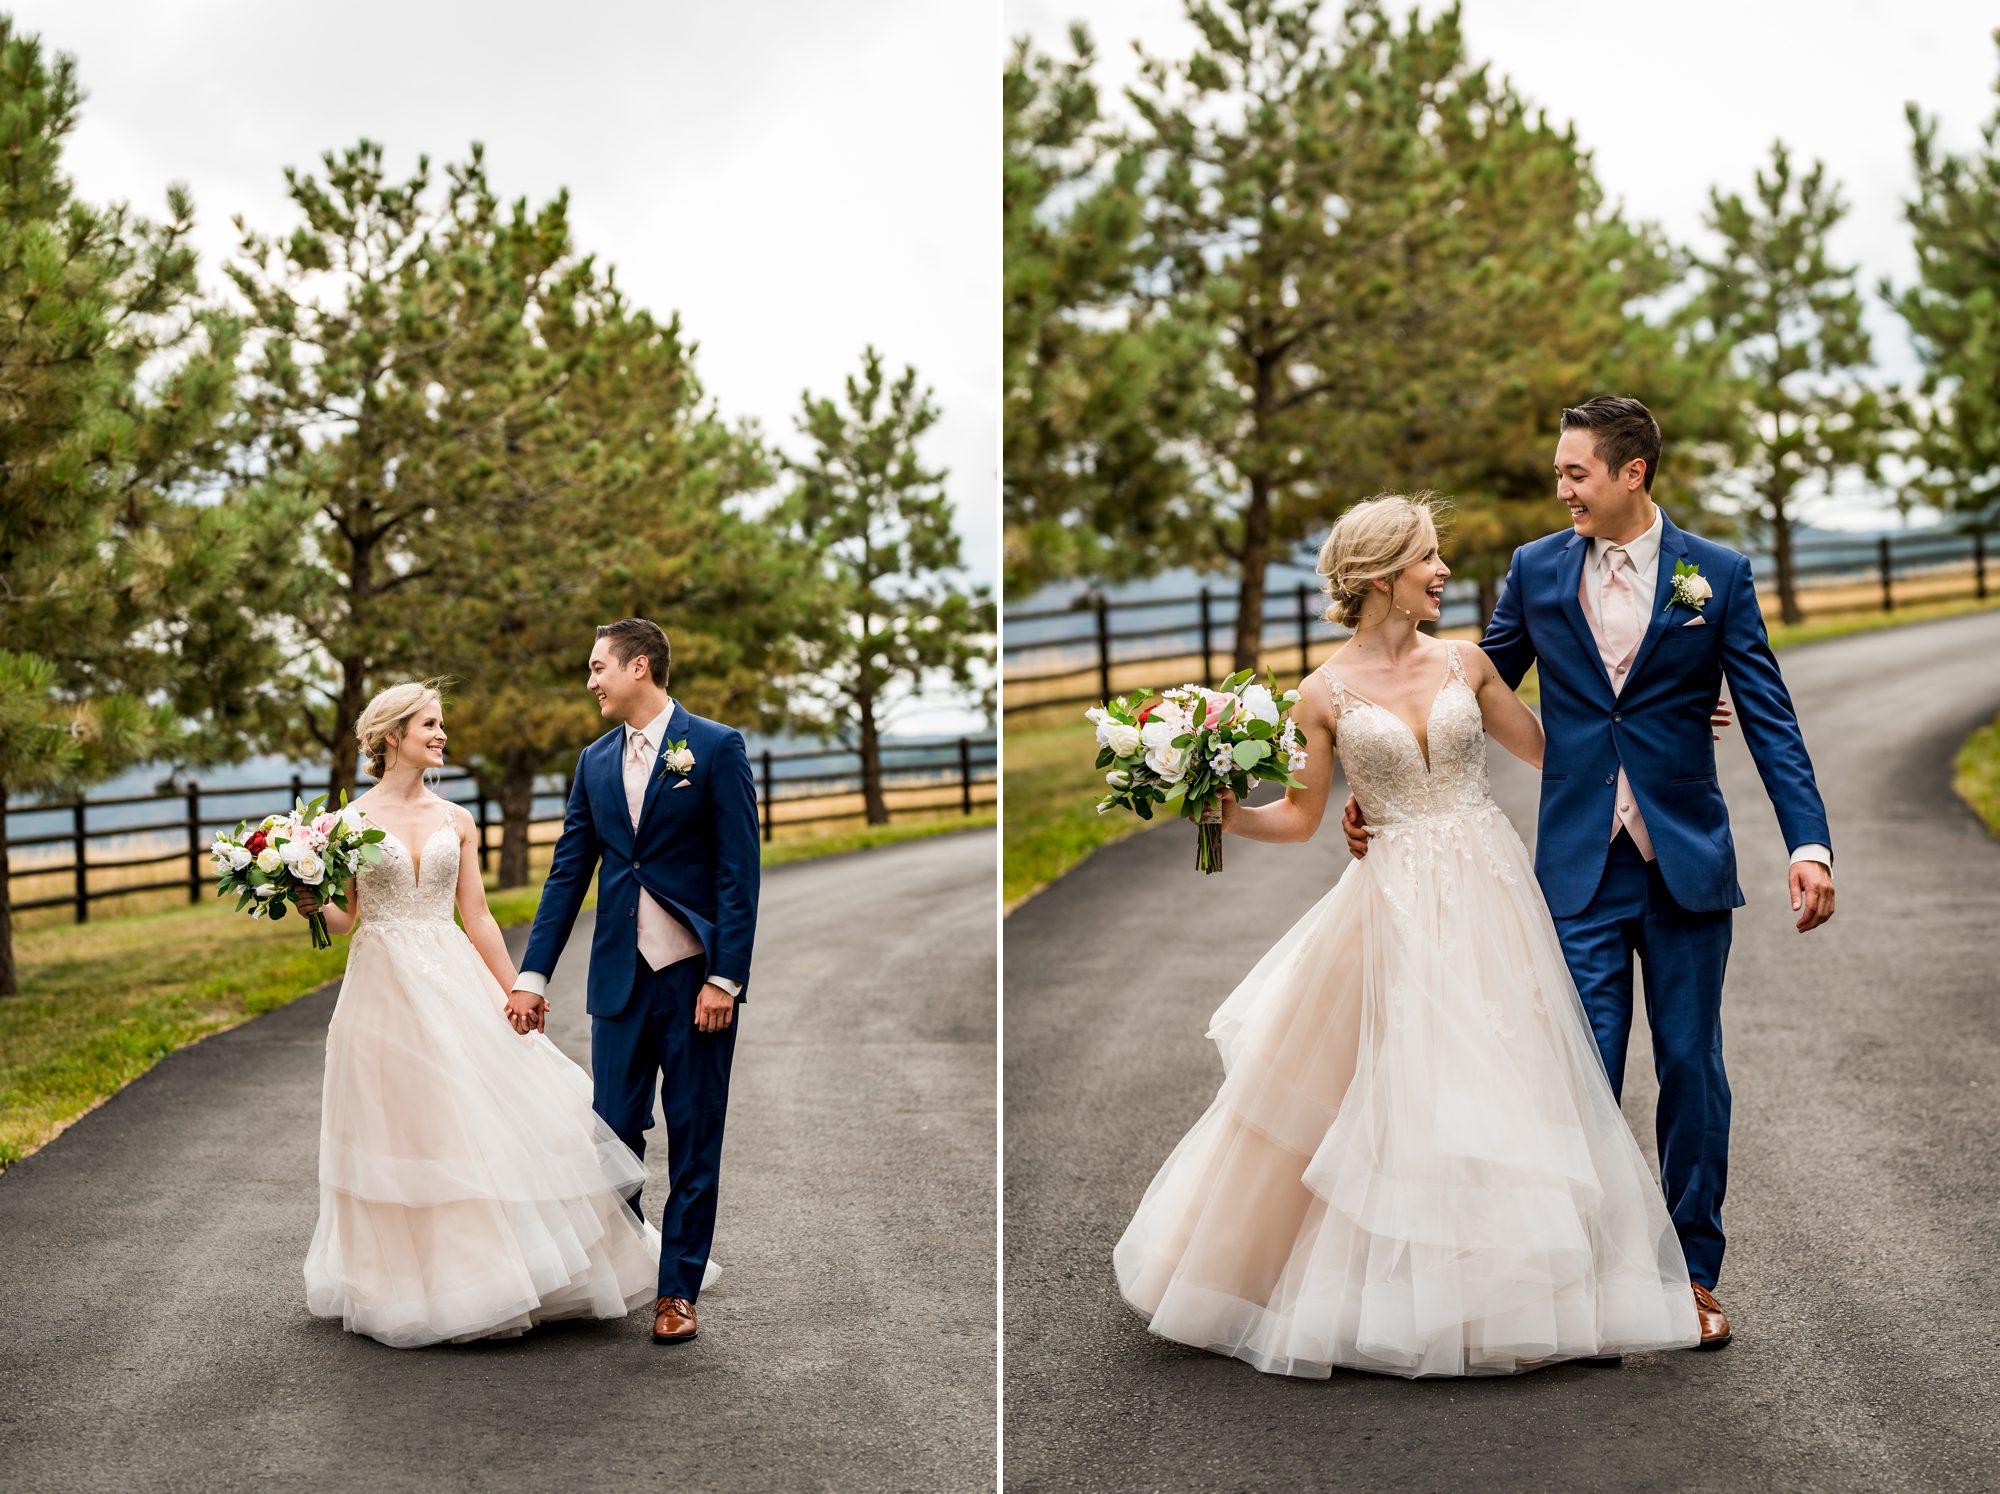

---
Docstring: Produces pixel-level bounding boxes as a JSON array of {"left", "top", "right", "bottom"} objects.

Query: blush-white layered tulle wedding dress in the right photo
[{"left": 1114, "top": 646, "right": 1698, "bottom": 1378}]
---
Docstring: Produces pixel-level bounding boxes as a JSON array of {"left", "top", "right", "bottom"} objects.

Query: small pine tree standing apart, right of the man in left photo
[{"left": 776, "top": 348, "right": 994, "bottom": 824}]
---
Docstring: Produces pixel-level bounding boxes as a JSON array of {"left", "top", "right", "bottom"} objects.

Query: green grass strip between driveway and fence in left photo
[{"left": 0, "top": 806, "right": 994, "bottom": 1170}]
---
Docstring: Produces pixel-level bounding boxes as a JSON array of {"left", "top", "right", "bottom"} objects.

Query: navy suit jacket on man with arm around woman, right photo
[{"left": 1480, "top": 514, "right": 1832, "bottom": 918}]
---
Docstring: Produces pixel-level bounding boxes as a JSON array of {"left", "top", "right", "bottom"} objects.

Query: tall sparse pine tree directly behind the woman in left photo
[{"left": 228, "top": 140, "right": 590, "bottom": 792}]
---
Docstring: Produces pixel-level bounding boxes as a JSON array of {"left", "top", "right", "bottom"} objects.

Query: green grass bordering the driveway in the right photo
[{"left": 1000, "top": 598, "right": 2000, "bottom": 912}]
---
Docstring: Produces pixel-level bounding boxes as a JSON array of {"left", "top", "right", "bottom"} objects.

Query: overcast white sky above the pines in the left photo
[{"left": 21, "top": 0, "right": 1000, "bottom": 582}]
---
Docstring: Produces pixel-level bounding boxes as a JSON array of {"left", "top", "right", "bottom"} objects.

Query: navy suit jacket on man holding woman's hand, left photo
[{"left": 522, "top": 700, "right": 760, "bottom": 1016}]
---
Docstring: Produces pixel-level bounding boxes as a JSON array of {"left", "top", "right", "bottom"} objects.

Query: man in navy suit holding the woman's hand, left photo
[{"left": 508, "top": 618, "right": 758, "bottom": 1344}]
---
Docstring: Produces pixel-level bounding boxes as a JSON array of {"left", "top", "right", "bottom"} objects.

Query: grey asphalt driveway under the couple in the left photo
[{"left": 0, "top": 830, "right": 996, "bottom": 1494}]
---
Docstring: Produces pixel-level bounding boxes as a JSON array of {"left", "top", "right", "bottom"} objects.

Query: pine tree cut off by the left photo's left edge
[{"left": 0, "top": 18, "right": 274, "bottom": 996}]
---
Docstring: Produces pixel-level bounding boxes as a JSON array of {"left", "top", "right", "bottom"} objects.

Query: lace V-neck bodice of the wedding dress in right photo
[{"left": 1320, "top": 644, "right": 1492, "bottom": 826}]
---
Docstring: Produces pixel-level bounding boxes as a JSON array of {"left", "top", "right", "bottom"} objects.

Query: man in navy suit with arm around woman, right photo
[{"left": 1346, "top": 396, "right": 1834, "bottom": 1348}]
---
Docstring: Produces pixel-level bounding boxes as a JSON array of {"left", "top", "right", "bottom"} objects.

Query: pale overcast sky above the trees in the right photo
[{"left": 1006, "top": 0, "right": 2000, "bottom": 524}]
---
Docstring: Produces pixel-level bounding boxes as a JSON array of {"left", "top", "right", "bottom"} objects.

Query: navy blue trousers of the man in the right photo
[{"left": 1556, "top": 830, "right": 1730, "bottom": 1288}]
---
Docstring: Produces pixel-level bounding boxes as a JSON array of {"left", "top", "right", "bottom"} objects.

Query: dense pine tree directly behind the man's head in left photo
[{"left": 412, "top": 290, "right": 814, "bottom": 886}]
